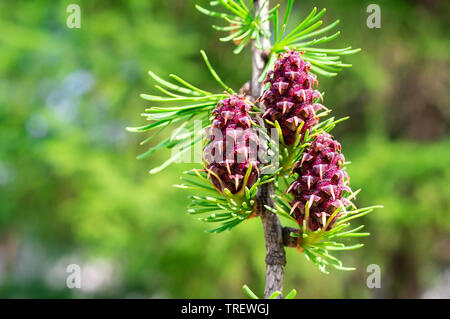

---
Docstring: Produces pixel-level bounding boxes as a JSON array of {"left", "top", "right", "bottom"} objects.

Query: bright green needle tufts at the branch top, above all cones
[{"left": 196, "top": 0, "right": 361, "bottom": 81}]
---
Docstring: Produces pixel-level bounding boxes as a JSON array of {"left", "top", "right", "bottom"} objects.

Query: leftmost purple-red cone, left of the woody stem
[{"left": 203, "top": 94, "right": 260, "bottom": 194}]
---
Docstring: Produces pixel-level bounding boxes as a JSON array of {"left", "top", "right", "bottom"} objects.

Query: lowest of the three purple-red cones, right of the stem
[{"left": 287, "top": 133, "right": 352, "bottom": 231}]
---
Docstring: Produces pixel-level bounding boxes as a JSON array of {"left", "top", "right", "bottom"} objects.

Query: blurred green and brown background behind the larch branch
[{"left": 0, "top": 0, "right": 450, "bottom": 298}]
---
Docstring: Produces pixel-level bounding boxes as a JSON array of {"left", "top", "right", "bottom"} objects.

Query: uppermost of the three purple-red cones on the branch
[{"left": 260, "top": 48, "right": 325, "bottom": 145}]
